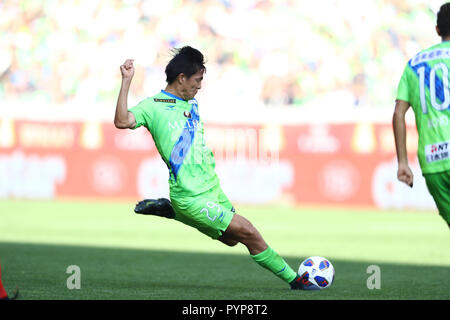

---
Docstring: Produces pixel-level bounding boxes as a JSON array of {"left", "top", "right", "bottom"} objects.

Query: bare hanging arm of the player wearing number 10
[{"left": 392, "top": 100, "right": 414, "bottom": 187}]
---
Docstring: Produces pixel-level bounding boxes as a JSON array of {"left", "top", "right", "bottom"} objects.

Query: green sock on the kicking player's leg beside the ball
[{"left": 251, "top": 247, "right": 297, "bottom": 283}]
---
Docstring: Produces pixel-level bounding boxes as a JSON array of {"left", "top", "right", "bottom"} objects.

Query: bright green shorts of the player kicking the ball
[{"left": 170, "top": 185, "right": 234, "bottom": 239}]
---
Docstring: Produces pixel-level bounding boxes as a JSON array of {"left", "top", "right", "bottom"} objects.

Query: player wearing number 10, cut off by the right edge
[{"left": 392, "top": 3, "right": 450, "bottom": 227}]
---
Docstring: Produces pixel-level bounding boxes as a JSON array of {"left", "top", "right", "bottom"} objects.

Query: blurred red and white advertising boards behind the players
[{"left": 0, "top": 119, "right": 434, "bottom": 209}]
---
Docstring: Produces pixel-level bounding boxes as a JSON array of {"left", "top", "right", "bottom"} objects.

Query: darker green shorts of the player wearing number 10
[{"left": 424, "top": 170, "right": 450, "bottom": 224}]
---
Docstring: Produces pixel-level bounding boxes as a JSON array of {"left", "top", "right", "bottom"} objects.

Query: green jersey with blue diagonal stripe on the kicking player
[{"left": 129, "top": 90, "right": 219, "bottom": 196}]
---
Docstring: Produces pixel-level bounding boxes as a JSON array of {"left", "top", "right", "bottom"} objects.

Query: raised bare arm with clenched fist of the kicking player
[{"left": 114, "top": 59, "right": 136, "bottom": 129}]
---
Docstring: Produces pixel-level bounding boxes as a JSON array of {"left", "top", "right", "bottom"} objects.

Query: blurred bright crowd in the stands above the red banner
[{"left": 0, "top": 0, "right": 441, "bottom": 112}]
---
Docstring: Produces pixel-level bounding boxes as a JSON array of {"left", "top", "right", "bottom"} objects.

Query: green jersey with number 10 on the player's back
[{"left": 397, "top": 42, "right": 450, "bottom": 174}]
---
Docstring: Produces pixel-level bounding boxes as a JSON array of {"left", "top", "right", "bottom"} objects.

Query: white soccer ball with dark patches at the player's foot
[{"left": 298, "top": 256, "right": 334, "bottom": 290}]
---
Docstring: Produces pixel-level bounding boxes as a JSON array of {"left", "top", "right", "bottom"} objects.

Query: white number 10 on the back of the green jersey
[{"left": 417, "top": 63, "right": 450, "bottom": 114}]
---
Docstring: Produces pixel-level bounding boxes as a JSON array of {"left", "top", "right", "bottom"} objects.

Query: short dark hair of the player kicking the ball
[{"left": 166, "top": 46, "right": 206, "bottom": 84}]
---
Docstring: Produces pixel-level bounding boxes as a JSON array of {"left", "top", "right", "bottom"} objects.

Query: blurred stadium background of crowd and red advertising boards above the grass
[{"left": 0, "top": 0, "right": 440, "bottom": 209}]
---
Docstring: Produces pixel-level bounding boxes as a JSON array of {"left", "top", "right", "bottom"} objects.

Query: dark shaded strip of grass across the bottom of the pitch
[{"left": 0, "top": 242, "right": 450, "bottom": 300}]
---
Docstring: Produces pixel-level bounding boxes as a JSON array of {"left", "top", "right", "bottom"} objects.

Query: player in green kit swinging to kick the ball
[{"left": 114, "top": 46, "right": 304, "bottom": 289}]
